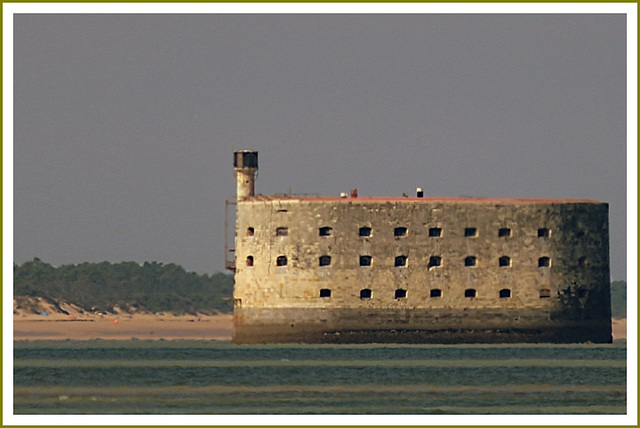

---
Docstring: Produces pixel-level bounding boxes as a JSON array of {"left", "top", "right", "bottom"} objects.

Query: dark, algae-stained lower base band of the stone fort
[{"left": 233, "top": 309, "right": 612, "bottom": 344}]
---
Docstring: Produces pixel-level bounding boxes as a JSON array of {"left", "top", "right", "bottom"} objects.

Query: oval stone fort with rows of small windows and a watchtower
[{"left": 229, "top": 150, "right": 612, "bottom": 344}]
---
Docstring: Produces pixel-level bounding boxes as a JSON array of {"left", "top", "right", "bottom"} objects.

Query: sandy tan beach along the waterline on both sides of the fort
[{"left": 13, "top": 313, "right": 627, "bottom": 341}]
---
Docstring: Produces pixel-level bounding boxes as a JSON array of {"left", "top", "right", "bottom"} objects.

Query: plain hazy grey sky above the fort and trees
[{"left": 5, "top": 8, "right": 627, "bottom": 279}]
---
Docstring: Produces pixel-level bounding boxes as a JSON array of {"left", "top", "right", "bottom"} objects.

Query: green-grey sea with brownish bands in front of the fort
[{"left": 13, "top": 340, "right": 628, "bottom": 415}]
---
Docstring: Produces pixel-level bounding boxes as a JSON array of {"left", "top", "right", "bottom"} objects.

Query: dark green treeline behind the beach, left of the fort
[{"left": 13, "top": 258, "right": 233, "bottom": 314}]
